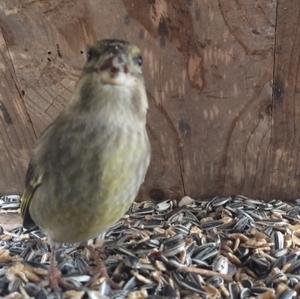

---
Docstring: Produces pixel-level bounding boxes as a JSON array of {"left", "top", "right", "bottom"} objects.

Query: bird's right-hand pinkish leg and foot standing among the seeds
[{"left": 86, "top": 245, "right": 120, "bottom": 289}]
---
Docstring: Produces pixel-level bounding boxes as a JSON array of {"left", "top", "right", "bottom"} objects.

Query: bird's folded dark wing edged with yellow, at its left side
[{"left": 21, "top": 162, "right": 43, "bottom": 228}]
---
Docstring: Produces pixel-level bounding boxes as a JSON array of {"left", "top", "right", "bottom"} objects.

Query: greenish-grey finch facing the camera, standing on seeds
[{"left": 21, "top": 39, "right": 151, "bottom": 289}]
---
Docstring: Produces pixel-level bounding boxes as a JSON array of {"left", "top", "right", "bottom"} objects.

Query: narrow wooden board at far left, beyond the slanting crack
[{"left": 0, "top": 27, "right": 35, "bottom": 193}]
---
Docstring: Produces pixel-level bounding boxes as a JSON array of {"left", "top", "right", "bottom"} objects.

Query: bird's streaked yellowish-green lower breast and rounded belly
[{"left": 30, "top": 127, "right": 150, "bottom": 243}]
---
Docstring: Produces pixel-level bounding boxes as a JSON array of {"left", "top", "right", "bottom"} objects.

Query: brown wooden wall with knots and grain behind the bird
[{"left": 0, "top": 0, "right": 300, "bottom": 200}]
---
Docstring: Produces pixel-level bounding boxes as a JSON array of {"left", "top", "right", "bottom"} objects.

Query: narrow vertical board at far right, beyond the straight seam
[{"left": 266, "top": 0, "right": 300, "bottom": 198}]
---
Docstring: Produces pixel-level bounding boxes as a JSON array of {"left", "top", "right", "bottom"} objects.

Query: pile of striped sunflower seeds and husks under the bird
[{"left": 0, "top": 195, "right": 300, "bottom": 299}]
